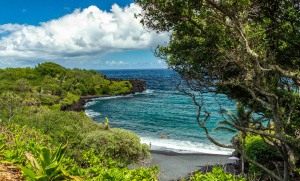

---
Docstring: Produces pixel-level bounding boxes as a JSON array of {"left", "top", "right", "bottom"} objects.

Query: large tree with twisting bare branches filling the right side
[{"left": 136, "top": 0, "right": 300, "bottom": 180}]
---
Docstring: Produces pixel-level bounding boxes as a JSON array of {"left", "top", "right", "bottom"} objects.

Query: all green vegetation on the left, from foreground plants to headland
[{"left": 0, "top": 63, "right": 158, "bottom": 180}]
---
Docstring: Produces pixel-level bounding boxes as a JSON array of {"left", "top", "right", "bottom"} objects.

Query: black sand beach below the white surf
[{"left": 129, "top": 150, "right": 230, "bottom": 181}]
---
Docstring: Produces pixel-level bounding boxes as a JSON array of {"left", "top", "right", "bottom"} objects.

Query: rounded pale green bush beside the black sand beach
[{"left": 82, "top": 128, "right": 150, "bottom": 166}]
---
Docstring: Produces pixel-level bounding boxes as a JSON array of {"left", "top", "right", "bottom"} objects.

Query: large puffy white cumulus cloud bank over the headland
[{"left": 0, "top": 3, "right": 169, "bottom": 65}]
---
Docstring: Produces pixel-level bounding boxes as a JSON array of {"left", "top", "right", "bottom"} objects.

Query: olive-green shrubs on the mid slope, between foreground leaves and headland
[{"left": 13, "top": 107, "right": 150, "bottom": 166}]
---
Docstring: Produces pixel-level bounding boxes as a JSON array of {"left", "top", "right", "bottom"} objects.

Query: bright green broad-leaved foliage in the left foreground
[{"left": 0, "top": 124, "right": 159, "bottom": 181}]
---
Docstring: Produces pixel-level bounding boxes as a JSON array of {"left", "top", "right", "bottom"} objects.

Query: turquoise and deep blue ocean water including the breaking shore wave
[{"left": 86, "top": 69, "right": 235, "bottom": 154}]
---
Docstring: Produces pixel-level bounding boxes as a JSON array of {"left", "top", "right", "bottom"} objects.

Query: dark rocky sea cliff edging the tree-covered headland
[{"left": 61, "top": 79, "right": 147, "bottom": 112}]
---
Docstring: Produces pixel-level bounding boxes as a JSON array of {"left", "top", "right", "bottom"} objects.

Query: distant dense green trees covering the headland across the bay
[{"left": 0, "top": 62, "right": 132, "bottom": 99}]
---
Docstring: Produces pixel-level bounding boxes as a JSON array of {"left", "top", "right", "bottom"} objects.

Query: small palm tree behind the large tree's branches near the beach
[{"left": 213, "top": 104, "right": 253, "bottom": 175}]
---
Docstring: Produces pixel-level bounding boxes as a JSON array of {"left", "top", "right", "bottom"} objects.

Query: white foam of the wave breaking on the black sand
[{"left": 141, "top": 137, "right": 233, "bottom": 155}]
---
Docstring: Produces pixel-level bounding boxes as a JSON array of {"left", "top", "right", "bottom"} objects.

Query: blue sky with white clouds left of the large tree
[{"left": 0, "top": 0, "right": 169, "bottom": 69}]
